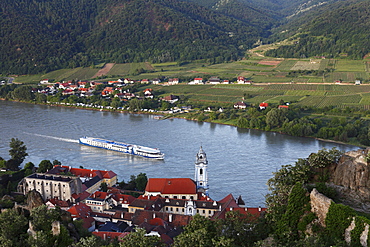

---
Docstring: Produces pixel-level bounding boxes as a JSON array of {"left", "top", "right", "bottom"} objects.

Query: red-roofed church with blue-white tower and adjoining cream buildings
[{"left": 128, "top": 147, "right": 264, "bottom": 218}]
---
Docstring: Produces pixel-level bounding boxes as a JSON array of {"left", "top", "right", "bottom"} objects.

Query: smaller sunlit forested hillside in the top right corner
[{"left": 266, "top": 1, "right": 370, "bottom": 59}]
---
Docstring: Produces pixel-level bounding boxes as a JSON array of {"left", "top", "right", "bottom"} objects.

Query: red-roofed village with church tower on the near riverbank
[{"left": 18, "top": 147, "right": 266, "bottom": 244}]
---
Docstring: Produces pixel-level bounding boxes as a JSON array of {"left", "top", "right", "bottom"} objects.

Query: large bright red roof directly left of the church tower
[{"left": 145, "top": 178, "right": 197, "bottom": 194}]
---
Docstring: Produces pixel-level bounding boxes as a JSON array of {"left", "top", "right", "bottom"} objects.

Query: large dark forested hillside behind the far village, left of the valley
[{"left": 0, "top": 0, "right": 271, "bottom": 74}]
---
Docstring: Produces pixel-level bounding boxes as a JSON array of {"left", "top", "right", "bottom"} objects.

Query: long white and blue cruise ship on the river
[{"left": 79, "top": 136, "right": 164, "bottom": 160}]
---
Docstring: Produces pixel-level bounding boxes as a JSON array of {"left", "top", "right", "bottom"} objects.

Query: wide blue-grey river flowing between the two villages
[{"left": 0, "top": 101, "right": 358, "bottom": 207}]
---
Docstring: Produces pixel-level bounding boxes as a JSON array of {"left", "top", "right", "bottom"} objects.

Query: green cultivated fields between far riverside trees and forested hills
[{"left": 10, "top": 54, "right": 370, "bottom": 109}]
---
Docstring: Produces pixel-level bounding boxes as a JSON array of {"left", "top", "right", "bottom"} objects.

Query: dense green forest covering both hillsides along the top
[{"left": 0, "top": 0, "right": 369, "bottom": 75}]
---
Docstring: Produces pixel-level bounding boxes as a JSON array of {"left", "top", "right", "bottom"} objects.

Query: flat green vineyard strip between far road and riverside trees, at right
[{"left": 163, "top": 84, "right": 370, "bottom": 109}]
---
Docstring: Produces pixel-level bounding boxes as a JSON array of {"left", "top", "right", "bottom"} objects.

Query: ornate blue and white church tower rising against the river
[{"left": 195, "top": 146, "right": 208, "bottom": 195}]
